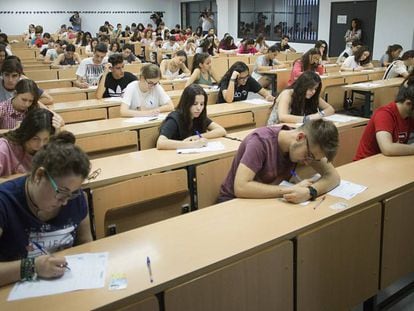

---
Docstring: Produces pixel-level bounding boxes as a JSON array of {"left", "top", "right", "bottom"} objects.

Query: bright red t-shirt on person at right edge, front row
[{"left": 354, "top": 102, "right": 414, "bottom": 161}]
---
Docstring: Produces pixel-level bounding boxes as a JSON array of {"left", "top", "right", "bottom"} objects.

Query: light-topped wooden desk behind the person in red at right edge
[{"left": 343, "top": 78, "right": 404, "bottom": 117}]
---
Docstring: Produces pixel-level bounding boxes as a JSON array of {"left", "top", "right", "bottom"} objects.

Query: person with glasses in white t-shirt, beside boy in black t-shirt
[{"left": 121, "top": 64, "right": 174, "bottom": 117}]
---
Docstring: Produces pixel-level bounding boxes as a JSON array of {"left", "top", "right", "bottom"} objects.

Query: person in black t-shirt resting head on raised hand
[{"left": 218, "top": 62, "right": 275, "bottom": 103}]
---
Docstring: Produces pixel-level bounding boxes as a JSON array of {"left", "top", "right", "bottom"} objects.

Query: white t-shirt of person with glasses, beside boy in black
[{"left": 122, "top": 81, "right": 171, "bottom": 110}]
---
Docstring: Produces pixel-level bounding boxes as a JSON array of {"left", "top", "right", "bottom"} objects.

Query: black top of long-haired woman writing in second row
[{"left": 160, "top": 111, "right": 213, "bottom": 140}]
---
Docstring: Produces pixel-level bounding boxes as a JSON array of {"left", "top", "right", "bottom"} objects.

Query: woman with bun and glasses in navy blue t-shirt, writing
[{"left": 0, "top": 132, "right": 92, "bottom": 285}]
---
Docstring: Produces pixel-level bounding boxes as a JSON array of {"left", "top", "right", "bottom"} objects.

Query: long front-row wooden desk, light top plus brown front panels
[{"left": 0, "top": 155, "right": 414, "bottom": 311}]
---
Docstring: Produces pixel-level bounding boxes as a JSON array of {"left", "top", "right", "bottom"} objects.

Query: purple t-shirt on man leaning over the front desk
[{"left": 218, "top": 125, "right": 294, "bottom": 202}]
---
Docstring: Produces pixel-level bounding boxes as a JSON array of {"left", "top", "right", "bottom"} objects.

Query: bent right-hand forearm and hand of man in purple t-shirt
[{"left": 283, "top": 158, "right": 341, "bottom": 203}]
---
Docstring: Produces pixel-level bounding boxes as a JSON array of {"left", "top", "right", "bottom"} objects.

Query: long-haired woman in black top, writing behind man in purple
[{"left": 157, "top": 84, "right": 226, "bottom": 149}]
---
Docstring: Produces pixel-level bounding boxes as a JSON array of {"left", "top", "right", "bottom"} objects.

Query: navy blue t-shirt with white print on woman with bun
[{"left": 0, "top": 176, "right": 87, "bottom": 261}]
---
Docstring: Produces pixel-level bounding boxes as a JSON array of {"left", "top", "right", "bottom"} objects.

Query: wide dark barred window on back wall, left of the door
[{"left": 238, "top": 0, "right": 319, "bottom": 43}]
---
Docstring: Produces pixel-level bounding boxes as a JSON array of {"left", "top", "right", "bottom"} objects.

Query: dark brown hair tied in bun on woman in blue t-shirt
[{"left": 32, "top": 131, "right": 90, "bottom": 179}]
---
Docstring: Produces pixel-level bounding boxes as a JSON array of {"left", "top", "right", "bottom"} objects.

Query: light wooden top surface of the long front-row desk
[{"left": 0, "top": 155, "right": 414, "bottom": 310}]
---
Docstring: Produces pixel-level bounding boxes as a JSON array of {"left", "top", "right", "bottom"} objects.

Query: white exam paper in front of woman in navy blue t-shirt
[{"left": 7, "top": 253, "right": 108, "bottom": 301}]
